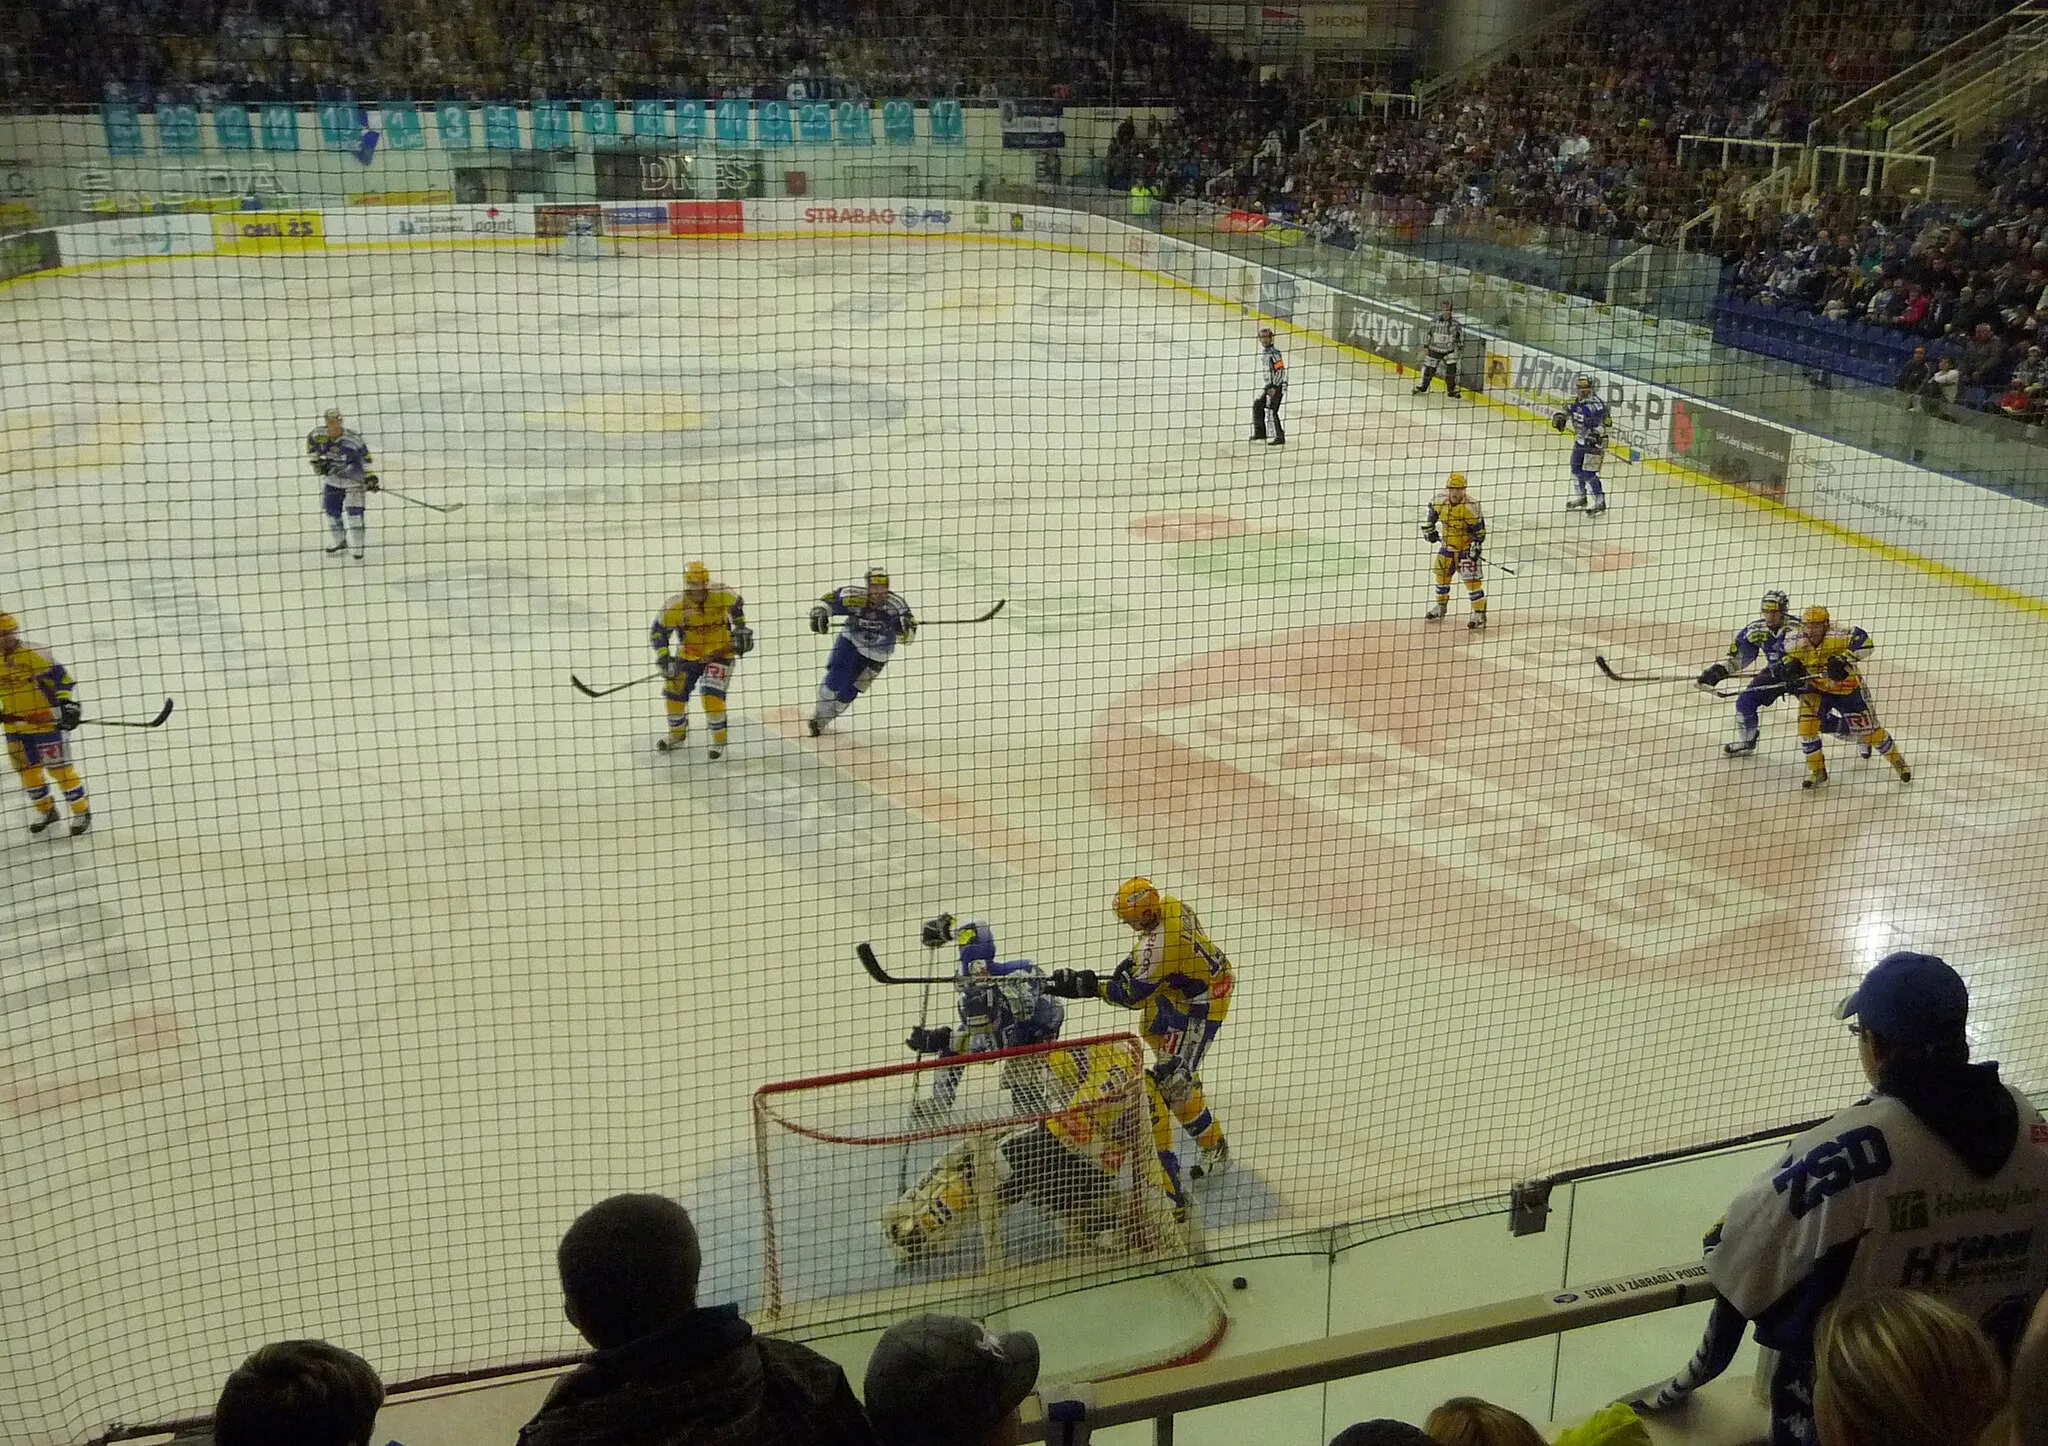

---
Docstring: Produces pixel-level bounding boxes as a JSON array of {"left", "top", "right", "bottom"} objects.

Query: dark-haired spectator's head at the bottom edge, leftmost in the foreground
[{"left": 213, "top": 1342, "right": 383, "bottom": 1446}]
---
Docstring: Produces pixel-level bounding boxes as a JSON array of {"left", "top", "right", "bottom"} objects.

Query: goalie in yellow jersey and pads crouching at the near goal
[{"left": 881, "top": 1040, "right": 1186, "bottom": 1262}]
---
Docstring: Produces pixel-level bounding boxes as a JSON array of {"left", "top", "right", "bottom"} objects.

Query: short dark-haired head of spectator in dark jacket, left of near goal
[{"left": 555, "top": 1194, "right": 705, "bottom": 1350}]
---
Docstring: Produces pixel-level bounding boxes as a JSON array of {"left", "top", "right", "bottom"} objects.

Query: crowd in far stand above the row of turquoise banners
[{"left": 0, "top": 0, "right": 1247, "bottom": 104}]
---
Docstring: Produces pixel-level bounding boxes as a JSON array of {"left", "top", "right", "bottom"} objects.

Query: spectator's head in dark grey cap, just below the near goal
[{"left": 862, "top": 1315, "right": 1038, "bottom": 1446}]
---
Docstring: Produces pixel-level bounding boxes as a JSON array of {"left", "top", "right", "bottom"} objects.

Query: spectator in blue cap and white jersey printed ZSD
[{"left": 1634, "top": 952, "right": 2048, "bottom": 1446}]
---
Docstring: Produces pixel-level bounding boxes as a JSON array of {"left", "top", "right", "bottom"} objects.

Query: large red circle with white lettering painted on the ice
[{"left": 1094, "top": 616, "right": 2048, "bottom": 979}]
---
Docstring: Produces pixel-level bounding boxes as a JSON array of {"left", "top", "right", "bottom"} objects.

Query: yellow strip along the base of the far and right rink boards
[{"left": 0, "top": 221, "right": 2048, "bottom": 616}]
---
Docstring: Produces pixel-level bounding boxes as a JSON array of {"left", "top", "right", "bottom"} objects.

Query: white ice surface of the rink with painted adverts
[{"left": 0, "top": 238, "right": 2048, "bottom": 1440}]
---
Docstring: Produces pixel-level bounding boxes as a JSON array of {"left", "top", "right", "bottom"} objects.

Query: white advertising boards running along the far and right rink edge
[{"left": 16, "top": 197, "right": 2048, "bottom": 610}]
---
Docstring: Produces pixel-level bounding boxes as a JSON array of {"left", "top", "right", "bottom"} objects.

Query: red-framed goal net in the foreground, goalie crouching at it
[{"left": 754, "top": 1034, "right": 1198, "bottom": 1329}]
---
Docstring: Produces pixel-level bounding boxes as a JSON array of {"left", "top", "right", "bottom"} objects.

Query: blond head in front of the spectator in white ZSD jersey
[{"left": 1812, "top": 1290, "right": 2005, "bottom": 1446}]
